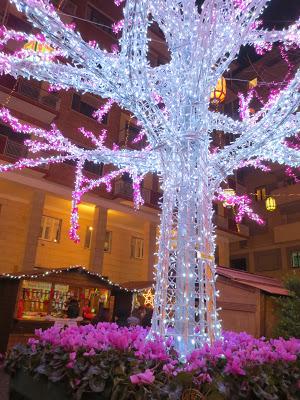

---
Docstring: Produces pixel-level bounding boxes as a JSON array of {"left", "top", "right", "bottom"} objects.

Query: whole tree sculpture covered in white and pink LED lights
[{"left": 0, "top": 0, "right": 300, "bottom": 355}]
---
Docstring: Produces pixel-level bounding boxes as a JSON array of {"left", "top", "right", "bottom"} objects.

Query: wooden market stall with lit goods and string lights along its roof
[{"left": 0, "top": 266, "right": 133, "bottom": 352}]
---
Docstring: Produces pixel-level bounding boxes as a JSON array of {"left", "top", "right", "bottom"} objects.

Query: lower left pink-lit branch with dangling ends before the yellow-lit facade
[{"left": 0, "top": 108, "right": 144, "bottom": 243}]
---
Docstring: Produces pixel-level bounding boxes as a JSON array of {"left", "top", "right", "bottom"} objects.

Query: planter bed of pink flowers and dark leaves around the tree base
[{"left": 5, "top": 323, "right": 300, "bottom": 400}]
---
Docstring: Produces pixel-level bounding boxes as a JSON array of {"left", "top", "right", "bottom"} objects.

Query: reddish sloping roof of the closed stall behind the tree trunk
[{"left": 124, "top": 266, "right": 289, "bottom": 296}]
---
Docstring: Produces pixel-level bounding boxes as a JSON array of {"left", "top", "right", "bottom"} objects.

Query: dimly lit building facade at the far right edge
[{"left": 225, "top": 47, "right": 300, "bottom": 280}]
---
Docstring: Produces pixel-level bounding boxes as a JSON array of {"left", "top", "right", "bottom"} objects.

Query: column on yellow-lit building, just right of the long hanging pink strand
[{"left": 89, "top": 206, "right": 107, "bottom": 274}]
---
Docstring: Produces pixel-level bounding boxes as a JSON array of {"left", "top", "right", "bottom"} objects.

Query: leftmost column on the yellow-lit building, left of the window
[{"left": 21, "top": 191, "right": 46, "bottom": 271}]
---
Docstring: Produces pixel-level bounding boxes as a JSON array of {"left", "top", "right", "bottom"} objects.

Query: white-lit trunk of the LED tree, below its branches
[{"left": 152, "top": 143, "right": 221, "bottom": 354}]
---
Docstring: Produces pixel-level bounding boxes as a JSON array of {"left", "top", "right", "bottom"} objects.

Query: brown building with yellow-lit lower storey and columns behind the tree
[{"left": 0, "top": 0, "right": 286, "bottom": 283}]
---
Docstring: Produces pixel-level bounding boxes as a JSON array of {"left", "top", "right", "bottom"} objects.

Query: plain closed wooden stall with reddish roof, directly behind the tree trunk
[{"left": 124, "top": 267, "right": 289, "bottom": 337}]
